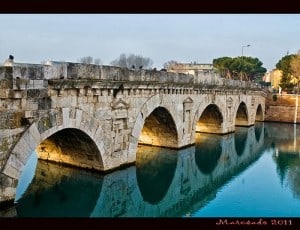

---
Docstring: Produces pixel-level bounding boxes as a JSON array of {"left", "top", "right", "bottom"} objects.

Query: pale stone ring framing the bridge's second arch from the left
[{"left": 128, "top": 94, "right": 182, "bottom": 162}]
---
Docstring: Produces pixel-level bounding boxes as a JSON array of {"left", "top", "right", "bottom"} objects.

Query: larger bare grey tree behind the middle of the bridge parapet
[{"left": 110, "top": 53, "right": 153, "bottom": 69}]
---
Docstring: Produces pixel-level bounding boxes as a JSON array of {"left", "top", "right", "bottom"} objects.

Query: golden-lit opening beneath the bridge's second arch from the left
[{"left": 139, "top": 107, "right": 178, "bottom": 148}]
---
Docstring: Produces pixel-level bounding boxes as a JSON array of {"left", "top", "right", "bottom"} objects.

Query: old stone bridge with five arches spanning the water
[{"left": 0, "top": 62, "right": 267, "bottom": 207}]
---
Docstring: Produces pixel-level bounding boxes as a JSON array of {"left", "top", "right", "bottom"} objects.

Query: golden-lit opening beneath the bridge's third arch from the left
[{"left": 196, "top": 104, "right": 223, "bottom": 133}]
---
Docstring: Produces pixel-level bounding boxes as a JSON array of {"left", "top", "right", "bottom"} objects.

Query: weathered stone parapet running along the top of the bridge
[{"left": 0, "top": 62, "right": 268, "bottom": 90}]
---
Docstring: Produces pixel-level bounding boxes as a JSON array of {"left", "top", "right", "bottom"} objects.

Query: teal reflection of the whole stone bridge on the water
[{"left": 17, "top": 124, "right": 264, "bottom": 217}]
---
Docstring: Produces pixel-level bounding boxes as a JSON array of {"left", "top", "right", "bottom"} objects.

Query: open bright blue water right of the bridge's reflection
[{"left": 193, "top": 151, "right": 300, "bottom": 217}]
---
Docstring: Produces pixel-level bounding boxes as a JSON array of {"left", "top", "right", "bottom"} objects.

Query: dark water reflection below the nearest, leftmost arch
[{"left": 15, "top": 160, "right": 103, "bottom": 217}]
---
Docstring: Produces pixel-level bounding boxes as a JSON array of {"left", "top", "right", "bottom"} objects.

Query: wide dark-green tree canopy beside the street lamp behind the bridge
[{"left": 213, "top": 56, "right": 267, "bottom": 81}]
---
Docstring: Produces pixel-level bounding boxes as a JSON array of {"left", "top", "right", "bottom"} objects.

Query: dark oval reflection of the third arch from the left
[{"left": 195, "top": 133, "right": 223, "bottom": 175}]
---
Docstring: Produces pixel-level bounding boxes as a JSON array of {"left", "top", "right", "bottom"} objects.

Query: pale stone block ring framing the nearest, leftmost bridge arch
[{"left": 0, "top": 108, "right": 109, "bottom": 203}]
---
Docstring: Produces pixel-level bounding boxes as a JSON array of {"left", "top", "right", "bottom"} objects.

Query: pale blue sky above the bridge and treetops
[{"left": 0, "top": 14, "right": 300, "bottom": 70}]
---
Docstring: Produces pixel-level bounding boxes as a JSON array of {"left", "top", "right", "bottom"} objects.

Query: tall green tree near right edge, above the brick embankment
[{"left": 276, "top": 54, "right": 296, "bottom": 91}]
